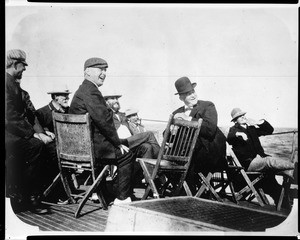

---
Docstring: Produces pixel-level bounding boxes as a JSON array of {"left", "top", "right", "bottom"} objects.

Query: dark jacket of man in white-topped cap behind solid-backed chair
[{"left": 36, "top": 101, "right": 69, "bottom": 133}]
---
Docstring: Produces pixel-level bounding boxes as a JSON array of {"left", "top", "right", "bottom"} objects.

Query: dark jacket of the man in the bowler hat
[{"left": 173, "top": 100, "right": 226, "bottom": 173}]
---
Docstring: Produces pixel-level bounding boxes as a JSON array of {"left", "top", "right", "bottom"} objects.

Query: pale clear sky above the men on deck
[{"left": 5, "top": 0, "right": 299, "bottom": 128}]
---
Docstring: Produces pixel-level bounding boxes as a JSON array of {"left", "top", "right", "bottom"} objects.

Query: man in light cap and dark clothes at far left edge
[{"left": 5, "top": 49, "right": 58, "bottom": 214}]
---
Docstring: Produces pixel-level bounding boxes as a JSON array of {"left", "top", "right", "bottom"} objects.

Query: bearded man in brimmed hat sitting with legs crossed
[{"left": 104, "top": 93, "right": 160, "bottom": 188}]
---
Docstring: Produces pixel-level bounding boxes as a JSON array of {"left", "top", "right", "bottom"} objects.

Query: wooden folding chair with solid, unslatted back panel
[{"left": 44, "top": 112, "right": 110, "bottom": 218}]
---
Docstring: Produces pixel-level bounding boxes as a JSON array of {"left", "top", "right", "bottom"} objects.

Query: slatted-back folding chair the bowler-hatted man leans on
[{"left": 137, "top": 114, "right": 202, "bottom": 200}]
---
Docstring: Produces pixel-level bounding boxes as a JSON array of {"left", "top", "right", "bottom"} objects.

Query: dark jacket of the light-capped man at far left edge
[{"left": 5, "top": 73, "right": 44, "bottom": 142}]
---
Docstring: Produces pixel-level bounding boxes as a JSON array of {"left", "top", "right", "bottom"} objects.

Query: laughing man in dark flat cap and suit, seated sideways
[{"left": 69, "top": 57, "right": 134, "bottom": 204}]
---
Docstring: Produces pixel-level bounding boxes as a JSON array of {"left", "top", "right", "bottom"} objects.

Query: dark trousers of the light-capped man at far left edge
[{"left": 5, "top": 137, "right": 58, "bottom": 200}]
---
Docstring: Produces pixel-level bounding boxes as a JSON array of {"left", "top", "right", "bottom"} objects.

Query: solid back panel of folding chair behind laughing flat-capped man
[{"left": 52, "top": 112, "right": 94, "bottom": 167}]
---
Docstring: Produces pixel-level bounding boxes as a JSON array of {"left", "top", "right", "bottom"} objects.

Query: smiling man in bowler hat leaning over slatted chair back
[{"left": 173, "top": 77, "right": 227, "bottom": 195}]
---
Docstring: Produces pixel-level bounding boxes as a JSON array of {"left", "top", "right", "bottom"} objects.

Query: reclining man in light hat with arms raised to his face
[{"left": 227, "top": 108, "right": 294, "bottom": 208}]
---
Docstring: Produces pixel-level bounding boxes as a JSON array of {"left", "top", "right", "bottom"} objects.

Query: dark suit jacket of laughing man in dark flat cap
[{"left": 69, "top": 80, "right": 121, "bottom": 158}]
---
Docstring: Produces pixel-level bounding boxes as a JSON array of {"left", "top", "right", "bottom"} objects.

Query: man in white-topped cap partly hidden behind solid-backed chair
[{"left": 36, "top": 87, "right": 71, "bottom": 133}]
